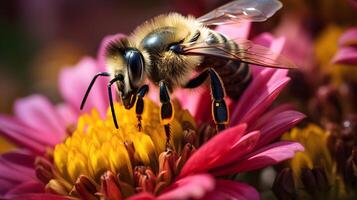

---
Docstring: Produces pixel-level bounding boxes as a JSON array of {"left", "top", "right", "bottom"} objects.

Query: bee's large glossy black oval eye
[{"left": 125, "top": 50, "right": 144, "bottom": 85}]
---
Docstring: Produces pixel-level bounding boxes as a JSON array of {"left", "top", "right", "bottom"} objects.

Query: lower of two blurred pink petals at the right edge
[{"left": 332, "top": 46, "right": 357, "bottom": 66}]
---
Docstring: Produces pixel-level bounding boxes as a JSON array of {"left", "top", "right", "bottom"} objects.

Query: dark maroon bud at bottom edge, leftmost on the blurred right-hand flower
[{"left": 272, "top": 168, "right": 296, "bottom": 200}]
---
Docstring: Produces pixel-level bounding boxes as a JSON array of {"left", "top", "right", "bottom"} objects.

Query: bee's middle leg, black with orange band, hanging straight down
[{"left": 159, "top": 81, "right": 175, "bottom": 149}]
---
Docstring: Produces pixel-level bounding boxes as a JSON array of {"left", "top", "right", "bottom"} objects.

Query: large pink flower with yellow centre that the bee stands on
[{"left": 0, "top": 22, "right": 304, "bottom": 199}]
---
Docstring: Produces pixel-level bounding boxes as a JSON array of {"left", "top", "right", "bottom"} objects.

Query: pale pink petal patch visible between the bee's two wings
[{"left": 216, "top": 22, "right": 251, "bottom": 39}]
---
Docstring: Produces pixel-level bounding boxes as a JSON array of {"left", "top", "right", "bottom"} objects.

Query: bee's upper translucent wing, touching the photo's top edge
[{"left": 198, "top": 0, "right": 282, "bottom": 25}]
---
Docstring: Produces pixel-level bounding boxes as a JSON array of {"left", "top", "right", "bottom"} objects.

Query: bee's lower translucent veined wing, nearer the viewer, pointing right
[{"left": 183, "top": 39, "right": 297, "bottom": 69}]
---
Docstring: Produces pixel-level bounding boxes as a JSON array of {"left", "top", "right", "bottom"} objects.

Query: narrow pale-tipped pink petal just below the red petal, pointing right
[{"left": 211, "top": 141, "right": 304, "bottom": 176}]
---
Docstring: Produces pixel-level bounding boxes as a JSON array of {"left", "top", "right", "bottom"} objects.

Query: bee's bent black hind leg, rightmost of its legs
[{"left": 184, "top": 68, "right": 229, "bottom": 132}]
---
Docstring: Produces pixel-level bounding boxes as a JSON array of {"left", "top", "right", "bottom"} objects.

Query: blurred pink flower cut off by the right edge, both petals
[{"left": 332, "top": 28, "right": 357, "bottom": 66}]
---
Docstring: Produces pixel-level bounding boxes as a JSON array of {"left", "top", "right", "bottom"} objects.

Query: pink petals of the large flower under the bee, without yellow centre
[{"left": 0, "top": 21, "right": 304, "bottom": 199}]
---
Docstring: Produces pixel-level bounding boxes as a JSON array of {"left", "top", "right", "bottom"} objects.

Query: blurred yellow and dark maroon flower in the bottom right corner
[{"left": 273, "top": 122, "right": 357, "bottom": 199}]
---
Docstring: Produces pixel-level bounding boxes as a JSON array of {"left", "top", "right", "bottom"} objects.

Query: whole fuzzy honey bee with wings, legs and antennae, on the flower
[{"left": 81, "top": 0, "right": 294, "bottom": 147}]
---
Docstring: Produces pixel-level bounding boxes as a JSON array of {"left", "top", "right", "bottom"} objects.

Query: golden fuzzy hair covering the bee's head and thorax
[{"left": 105, "top": 13, "right": 209, "bottom": 90}]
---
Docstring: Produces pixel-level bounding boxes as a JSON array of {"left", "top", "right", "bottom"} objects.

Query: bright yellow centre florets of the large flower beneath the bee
[{"left": 43, "top": 100, "right": 196, "bottom": 195}]
